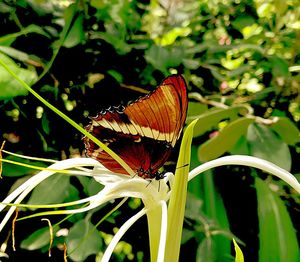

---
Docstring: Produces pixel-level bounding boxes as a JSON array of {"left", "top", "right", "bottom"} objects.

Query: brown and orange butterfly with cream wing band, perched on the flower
[{"left": 83, "top": 75, "right": 188, "bottom": 180}]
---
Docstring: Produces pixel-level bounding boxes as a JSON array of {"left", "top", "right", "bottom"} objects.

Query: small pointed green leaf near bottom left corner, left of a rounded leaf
[{"left": 21, "top": 227, "right": 58, "bottom": 250}]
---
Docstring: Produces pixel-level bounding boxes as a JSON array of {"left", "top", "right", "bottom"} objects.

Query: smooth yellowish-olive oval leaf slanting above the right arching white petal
[{"left": 198, "top": 117, "right": 254, "bottom": 161}]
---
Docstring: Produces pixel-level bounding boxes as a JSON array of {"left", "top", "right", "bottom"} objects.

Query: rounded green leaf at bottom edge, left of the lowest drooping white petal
[{"left": 66, "top": 219, "right": 102, "bottom": 261}]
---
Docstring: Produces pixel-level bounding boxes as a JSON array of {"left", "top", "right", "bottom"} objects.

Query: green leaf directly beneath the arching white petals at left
[{"left": 28, "top": 174, "right": 70, "bottom": 204}]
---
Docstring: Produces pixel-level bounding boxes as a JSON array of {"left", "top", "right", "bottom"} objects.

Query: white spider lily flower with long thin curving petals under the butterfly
[{"left": 0, "top": 152, "right": 300, "bottom": 261}]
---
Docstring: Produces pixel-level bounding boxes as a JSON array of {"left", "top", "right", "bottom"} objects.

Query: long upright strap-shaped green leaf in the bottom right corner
[{"left": 255, "top": 178, "right": 300, "bottom": 262}]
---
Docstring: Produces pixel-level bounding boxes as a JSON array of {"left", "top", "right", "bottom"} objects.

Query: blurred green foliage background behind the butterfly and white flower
[{"left": 0, "top": 0, "right": 300, "bottom": 261}]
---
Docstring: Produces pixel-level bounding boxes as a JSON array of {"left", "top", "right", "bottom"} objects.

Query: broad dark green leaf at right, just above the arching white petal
[{"left": 247, "top": 123, "right": 291, "bottom": 171}]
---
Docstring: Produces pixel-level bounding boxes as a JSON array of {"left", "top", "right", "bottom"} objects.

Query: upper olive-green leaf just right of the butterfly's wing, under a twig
[{"left": 187, "top": 106, "right": 246, "bottom": 137}]
